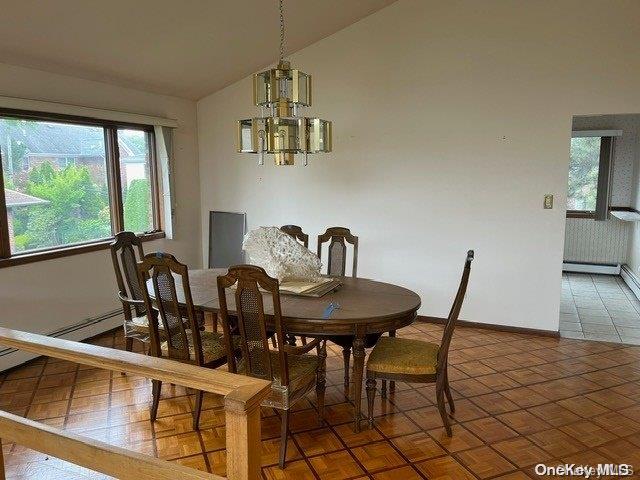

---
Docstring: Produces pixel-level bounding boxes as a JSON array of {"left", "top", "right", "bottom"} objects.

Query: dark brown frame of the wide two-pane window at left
[{"left": 0, "top": 108, "right": 165, "bottom": 268}]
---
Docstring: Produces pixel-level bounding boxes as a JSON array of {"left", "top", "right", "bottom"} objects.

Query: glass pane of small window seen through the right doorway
[{"left": 567, "top": 137, "right": 600, "bottom": 211}]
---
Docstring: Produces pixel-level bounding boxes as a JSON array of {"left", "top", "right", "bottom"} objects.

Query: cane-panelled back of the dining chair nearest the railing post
[{"left": 218, "top": 265, "right": 289, "bottom": 386}]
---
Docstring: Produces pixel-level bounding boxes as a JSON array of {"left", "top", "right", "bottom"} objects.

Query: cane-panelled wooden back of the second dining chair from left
[{"left": 138, "top": 252, "right": 204, "bottom": 365}]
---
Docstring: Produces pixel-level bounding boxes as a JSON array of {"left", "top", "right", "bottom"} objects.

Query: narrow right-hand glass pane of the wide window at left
[{"left": 118, "top": 129, "right": 154, "bottom": 233}]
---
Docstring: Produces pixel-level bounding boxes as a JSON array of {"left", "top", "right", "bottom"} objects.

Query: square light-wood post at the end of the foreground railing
[{"left": 224, "top": 387, "right": 270, "bottom": 480}]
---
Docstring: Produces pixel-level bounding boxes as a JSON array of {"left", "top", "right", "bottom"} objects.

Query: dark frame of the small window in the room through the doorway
[{"left": 566, "top": 131, "right": 615, "bottom": 220}]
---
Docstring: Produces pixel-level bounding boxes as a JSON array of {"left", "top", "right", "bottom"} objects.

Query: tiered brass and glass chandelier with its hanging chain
[{"left": 238, "top": 0, "right": 331, "bottom": 165}]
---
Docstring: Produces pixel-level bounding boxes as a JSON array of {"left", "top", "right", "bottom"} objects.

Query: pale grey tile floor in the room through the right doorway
[{"left": 560, "top": 273, "right": 640, "bottom": 345}]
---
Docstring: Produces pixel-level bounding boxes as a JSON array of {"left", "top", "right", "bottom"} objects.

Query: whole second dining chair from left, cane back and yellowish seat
[{"left": 137, "top": 252, "right": 233, "bottom": 430}]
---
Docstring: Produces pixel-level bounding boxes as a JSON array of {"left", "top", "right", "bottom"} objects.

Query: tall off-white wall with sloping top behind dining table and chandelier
[{"left": 198, "top": 0, "right": 640, "bottom": 330}]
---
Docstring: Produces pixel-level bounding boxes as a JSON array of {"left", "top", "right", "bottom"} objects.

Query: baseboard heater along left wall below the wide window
[{"left": 0, "top": 308, "right": 124, "bottom": 372}]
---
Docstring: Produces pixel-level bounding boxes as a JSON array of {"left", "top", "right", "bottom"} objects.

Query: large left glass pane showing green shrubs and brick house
[{"left": 0, "top": 117, "right": 112, "bottom": 253}]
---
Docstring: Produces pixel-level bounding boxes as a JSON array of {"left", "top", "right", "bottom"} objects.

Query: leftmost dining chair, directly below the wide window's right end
[{"left": 109, "top": 232, "right": 150, "bottom": 352}]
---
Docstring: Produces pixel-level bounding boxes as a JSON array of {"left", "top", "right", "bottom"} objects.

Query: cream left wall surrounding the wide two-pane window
[{"left": 0, "top": 64, "right": 201, "bottom": 350}]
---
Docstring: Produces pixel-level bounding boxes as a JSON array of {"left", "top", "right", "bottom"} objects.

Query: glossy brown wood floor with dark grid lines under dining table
[{"left": 0, "top": 323, "right": 640, "bottom": 480}]
